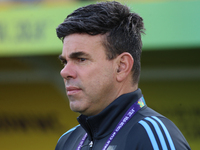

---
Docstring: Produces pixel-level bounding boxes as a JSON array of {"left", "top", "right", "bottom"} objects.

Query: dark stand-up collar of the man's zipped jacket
[{"left": 77, "top": 89, "right": 142, "bottom": 140}]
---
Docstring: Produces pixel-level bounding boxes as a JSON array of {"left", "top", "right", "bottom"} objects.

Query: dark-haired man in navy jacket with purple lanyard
[{"left": 56, "top": 1, "right": 190, "bottom": 150}]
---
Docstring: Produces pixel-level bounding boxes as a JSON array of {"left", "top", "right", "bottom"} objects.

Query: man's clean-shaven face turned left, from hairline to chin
[{"left": 60, "top": 34, "right": 117, "bottom": 116}]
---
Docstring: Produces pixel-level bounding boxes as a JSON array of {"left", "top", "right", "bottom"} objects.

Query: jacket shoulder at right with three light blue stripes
[{"left": 128, "top": 115, "right": 190, "bottom": 150}]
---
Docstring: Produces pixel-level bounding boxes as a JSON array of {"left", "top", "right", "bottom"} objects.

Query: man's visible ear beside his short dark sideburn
[{"left": 116, "top": 52, "right": 134, "bottom": 82}]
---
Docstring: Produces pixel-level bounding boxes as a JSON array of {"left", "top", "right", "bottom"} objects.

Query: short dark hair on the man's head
[{"left": 56, "top": 1, "right": 145, "bottom": 83}]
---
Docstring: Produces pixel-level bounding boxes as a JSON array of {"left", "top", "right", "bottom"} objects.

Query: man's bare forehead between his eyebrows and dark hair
[{"left": 62, "top": 34, "right": 105, "bottom": 56}]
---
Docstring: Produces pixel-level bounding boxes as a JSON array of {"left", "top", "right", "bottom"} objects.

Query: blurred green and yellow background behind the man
[{"left": 0, "top": 0, "right": 200, "bottom": 150}]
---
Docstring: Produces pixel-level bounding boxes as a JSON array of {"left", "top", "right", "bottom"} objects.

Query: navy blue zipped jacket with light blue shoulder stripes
[{"left": 55, "top": 89, "right": 190, "bottom": 150}]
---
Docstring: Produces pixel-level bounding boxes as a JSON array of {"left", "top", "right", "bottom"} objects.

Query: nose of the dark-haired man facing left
[{"left": 60, "top": 63, "right": 76, "bottom": 80}]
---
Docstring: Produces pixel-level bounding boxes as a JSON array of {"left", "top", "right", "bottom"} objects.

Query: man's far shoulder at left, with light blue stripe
[{"left": 55, "top": 125, "right": 84, "bottom": 150}]
